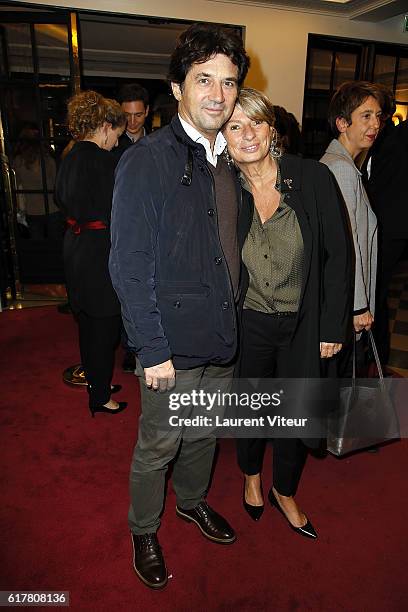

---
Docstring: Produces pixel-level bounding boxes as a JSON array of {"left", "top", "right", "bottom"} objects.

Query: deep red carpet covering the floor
[{"left": 0, "top": 307, "right": 408, "bottom": 612}]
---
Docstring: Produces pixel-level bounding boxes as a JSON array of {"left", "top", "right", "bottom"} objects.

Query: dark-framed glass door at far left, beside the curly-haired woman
[{"left": 0, "top": 7, "right": 76, "bottom": 304}]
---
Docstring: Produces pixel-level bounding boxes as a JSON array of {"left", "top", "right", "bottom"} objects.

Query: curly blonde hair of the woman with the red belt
[{"left": 68, "top": 91, "right": 126, "bottom": 140}]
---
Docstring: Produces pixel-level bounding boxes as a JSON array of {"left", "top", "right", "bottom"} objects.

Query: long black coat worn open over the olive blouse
[{"left": 243, "top": 155, "right": 353, "bottom": 447}]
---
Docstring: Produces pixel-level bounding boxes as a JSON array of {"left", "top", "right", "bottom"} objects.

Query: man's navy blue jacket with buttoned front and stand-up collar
[{"left": 109, "top": 117, "right": 252, "bottom": 369}]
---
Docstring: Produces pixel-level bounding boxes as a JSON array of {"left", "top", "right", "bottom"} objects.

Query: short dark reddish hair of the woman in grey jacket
[{"left": 328, "top": 81, "right": 384, "bottom": 138}]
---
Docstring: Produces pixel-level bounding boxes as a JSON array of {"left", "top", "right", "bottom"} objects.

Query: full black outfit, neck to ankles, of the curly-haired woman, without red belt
[{"left": 55, "top": 141, "right": 121, "bottom": 406}]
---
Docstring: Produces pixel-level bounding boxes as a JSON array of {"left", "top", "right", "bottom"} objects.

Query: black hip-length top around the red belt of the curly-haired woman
[{"left": 55, "top": 141, "right": 120, "bottom": 317}]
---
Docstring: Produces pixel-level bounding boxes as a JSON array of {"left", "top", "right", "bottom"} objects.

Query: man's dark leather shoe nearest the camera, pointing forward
[{"left": 130, "top": 533, "right": 167, "bottom": 589}]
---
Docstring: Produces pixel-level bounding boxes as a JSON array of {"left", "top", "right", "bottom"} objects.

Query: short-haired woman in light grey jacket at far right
[{"left": 320, "top": 81, "right": 383, "bottom": 376}]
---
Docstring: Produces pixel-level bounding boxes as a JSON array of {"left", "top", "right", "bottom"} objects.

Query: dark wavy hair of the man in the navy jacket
[{"left": 168, "top": 23, "right": 249, "bottom": 86}]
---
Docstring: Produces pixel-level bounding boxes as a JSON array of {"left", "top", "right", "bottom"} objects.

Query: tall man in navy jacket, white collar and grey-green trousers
[{"left": 110, "top": 24, "right": 250, "bottom": 588}]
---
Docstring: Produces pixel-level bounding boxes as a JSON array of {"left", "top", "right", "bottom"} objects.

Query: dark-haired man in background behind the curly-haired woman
[{"left": 118, "top": 83, "right": 149, "bottom": 152}]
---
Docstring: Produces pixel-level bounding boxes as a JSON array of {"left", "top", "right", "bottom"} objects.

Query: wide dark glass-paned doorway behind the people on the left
[{"left": 0, "top": 2, "right": 243, "bottom": 306}]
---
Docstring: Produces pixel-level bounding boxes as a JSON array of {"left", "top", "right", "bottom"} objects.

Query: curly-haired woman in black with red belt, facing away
[{"left": 55, "top": 91, "right": 126, "bottom": 416}]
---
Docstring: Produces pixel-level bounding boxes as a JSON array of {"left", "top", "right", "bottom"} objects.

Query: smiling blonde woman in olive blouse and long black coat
[{"left": 224, "top": 89, "right": 350, "bottom": 538}]
